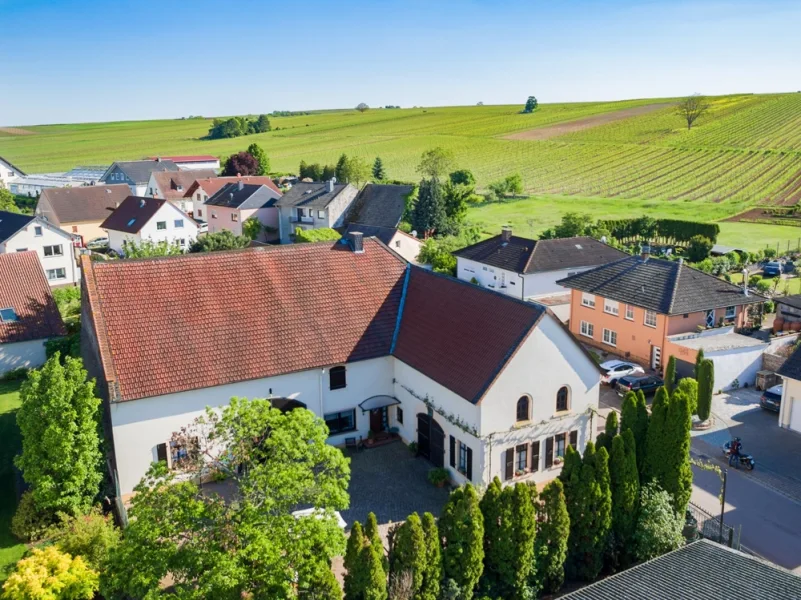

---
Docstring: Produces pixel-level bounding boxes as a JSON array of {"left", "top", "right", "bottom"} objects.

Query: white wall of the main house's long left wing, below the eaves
[{"left": 110, "top": 357, "right": 394, "bottom": 495}]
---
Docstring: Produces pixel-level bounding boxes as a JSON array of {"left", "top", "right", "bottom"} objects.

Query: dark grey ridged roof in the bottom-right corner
[{"left": 561, "top": 540, "right": 801, "bottom": 600}]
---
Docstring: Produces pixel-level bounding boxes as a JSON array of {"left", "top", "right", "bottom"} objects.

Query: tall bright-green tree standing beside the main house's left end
[{"left": 15, "top": 353, "right": 103, "bottom": 515}]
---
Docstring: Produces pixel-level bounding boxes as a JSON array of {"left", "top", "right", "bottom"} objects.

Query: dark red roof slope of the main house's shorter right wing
[{"left": 393, "top": 268, "right": 545, "bottom": 403}]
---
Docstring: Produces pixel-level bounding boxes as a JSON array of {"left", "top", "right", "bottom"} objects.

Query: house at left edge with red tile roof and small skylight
[{"left": 0, "top": 250, "right": 66, "bottom": 375}]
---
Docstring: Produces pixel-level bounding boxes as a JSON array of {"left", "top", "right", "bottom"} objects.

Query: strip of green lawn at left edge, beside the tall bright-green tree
[{"left": 0, "top": 381, "right": 25, "bottom": 582}]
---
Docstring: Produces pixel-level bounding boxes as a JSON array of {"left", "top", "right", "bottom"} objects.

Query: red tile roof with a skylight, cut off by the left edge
[{"left": 0, "top": 250, "right": 65, "bottom": 344}]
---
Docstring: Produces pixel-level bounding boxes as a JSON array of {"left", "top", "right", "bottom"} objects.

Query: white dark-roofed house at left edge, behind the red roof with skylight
[{"left": 0, "top": 210, "right": 81, "bottom": 286}]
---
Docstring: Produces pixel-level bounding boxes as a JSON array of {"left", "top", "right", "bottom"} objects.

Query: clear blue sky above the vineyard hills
[{"left": 0, "top": 0, "right": 801, "bottom": 125}]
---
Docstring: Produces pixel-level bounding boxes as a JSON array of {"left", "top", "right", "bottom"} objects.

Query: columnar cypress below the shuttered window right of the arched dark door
[{"left": 439, "top": 484, "right": 484, "bottom": 600}]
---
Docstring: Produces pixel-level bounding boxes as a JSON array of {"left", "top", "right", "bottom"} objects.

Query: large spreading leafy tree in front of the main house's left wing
[{"left": 101, "top": 398, "right": 350, "bottom": 600}]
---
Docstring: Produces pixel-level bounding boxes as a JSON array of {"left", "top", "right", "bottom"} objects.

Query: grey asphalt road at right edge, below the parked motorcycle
[{"left": 692, "top": 467, "right": 801, "bottom": 574}]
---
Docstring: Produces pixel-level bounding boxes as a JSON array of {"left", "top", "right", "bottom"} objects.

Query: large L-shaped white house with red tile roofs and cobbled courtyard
[{"left": 81, "top": 233, "right": 600, "bottom": 499}]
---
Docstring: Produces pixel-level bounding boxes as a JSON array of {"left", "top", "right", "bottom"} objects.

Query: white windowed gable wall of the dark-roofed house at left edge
[{"left": 0, "top": 219, "right": 81, "bottom": 286}]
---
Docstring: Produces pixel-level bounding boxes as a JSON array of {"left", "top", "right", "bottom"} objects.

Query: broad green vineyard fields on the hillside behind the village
[{"left": 0, "top": 93, "right": 801, "bottom": 247}]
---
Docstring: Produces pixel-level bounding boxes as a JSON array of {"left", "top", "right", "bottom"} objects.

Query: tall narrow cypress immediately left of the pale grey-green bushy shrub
[{"left": 609, "top": 429, "right": 640, "bottom": 567}]
